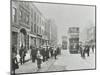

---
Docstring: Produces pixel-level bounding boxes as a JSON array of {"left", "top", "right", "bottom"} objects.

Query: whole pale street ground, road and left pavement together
[{"left": 15, "top": 50, "right": 95, "bottom": 73}]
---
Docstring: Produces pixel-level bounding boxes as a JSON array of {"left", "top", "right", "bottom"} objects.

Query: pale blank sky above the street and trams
[{"left": 34, "top": 3, "right": 95, "bottom": 43}]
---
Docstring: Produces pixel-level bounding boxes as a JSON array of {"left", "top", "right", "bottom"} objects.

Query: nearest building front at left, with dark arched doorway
[{"left": 11, "top": 1, "right": 30, "bottom": 50}]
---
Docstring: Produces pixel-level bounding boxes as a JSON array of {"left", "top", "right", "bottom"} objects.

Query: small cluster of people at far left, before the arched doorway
[{"left": 11, "top": 45, "right": 27, "bottom": 75}]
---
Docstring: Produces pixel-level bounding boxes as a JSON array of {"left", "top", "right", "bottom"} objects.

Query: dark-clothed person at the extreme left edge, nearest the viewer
[{"left": 11, "top": 48, "right": 19, "bottom": 75}]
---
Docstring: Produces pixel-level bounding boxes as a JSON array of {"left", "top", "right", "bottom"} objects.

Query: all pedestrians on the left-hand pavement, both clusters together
[{"left": 11, "top": 45, "right": 61, "bottom": 75}]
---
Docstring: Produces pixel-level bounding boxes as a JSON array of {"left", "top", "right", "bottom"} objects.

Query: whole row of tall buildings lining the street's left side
[{"left": 11, "top": 1, "right": 50, "bottom": 52}]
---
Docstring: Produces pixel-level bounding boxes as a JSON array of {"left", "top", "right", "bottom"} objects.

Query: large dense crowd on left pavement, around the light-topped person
[{"left": 30, "top": 46, "right": 61, "bottom": 69}]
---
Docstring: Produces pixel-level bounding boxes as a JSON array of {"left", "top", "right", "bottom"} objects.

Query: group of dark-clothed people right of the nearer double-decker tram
[{"left": 79, "top": 45, "right": 94, "bottom": 58}]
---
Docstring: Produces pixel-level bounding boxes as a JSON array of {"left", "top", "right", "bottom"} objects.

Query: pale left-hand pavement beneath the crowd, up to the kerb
[{"left": 15, "top": 58, "right": 55, "bottom": 73}]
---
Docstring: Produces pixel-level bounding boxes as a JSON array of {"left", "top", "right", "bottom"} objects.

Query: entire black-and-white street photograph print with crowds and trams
[{"left": 11, "top": 1, "right": 96, "bottom": 75}]
